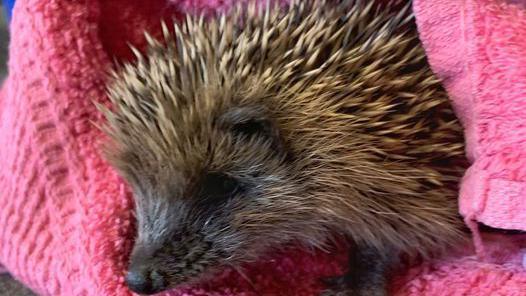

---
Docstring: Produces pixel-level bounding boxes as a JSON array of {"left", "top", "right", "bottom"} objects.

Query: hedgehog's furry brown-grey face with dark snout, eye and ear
[{"left": 116, "top": 100, "right": 322, "bottom": 294}]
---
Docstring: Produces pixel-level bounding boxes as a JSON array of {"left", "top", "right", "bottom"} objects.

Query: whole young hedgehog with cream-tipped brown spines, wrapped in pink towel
[{"left": 102, "top": 1, "right": 465, "bottom": 296}]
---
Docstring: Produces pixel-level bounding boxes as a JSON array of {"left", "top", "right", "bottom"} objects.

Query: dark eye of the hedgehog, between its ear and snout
[{"left": 201, "top": 173, "right": 241, "bottom": 201}]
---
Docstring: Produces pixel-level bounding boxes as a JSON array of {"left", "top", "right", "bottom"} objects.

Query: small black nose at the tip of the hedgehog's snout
[{"left": 125, "top": 268, "right": 166, "bottom": 295}]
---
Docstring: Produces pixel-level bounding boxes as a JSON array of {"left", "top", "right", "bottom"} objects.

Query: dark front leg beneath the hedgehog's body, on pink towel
[{"left": 320, "top": 248, "right": 398, "bottom": 296}]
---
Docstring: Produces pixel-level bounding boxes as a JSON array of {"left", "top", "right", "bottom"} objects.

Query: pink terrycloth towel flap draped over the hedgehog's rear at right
[{"left": 414, "top": 0, "right": 526, "bottom": 234}]
